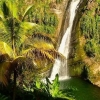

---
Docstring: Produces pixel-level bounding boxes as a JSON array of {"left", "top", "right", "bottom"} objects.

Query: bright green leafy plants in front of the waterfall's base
[{"left": 24, "top": 74, "right": 74, "bottom": 100}]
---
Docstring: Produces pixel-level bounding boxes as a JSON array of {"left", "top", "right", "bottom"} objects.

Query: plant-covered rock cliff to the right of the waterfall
[{"left": 69, "top": 0, "right": 100, "bottom": 87}]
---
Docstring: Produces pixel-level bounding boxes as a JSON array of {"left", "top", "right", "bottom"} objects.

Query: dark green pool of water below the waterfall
[{"left": 60, "top": 78, "right": 100, "bottom": 100}]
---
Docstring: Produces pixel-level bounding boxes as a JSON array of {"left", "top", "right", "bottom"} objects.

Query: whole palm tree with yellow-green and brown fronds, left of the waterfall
[{"left": 0, "top": 0, "right": 63, "bottom": 100}]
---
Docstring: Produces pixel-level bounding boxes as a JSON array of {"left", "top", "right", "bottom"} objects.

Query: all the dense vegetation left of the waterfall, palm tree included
[{"left": 0, "top": 0, "right": 73, "bottom": 100}]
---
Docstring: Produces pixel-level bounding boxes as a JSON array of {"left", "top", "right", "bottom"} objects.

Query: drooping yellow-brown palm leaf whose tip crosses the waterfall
[{"left": 23, "top": 48, "right": 66, "bottom": 69}]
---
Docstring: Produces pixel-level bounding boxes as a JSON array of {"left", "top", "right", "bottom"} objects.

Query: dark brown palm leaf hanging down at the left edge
[{"left": 0, "top": 62, "right": 11, "bottom": 85}]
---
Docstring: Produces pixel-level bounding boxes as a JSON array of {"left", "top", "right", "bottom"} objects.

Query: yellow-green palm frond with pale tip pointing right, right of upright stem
[{"left": 15, "top": 22, "right": 37, "bottom": 48}]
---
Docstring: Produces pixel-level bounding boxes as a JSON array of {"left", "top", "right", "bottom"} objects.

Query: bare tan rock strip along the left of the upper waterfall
[{"left": 52, "top": 0, "right": 70, "bottom": 48}]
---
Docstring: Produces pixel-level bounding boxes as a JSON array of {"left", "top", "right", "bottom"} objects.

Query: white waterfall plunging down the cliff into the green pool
[{"left": 50, "top": 0, "right": 81, "bottom": 80}]
